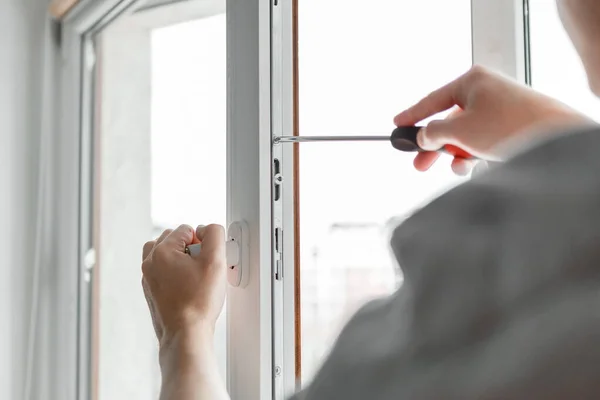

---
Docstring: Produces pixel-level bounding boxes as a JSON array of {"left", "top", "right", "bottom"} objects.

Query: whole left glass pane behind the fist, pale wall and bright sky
[{"left": 94, "top": 9, "right": 227, "bottom": 400}]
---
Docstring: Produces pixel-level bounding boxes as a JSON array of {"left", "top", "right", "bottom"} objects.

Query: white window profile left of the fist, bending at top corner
[{"left": 54, "top": 0, "right": 133, "bottom": 400}]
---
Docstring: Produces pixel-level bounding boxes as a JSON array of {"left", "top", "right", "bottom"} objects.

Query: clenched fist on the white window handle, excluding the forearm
[{"left": 142, "top": 225, "right": 227, "bottom": 347}]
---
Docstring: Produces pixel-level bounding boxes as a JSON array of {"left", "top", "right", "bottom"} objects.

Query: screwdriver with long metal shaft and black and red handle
[{"left": 273, "top": 126, "right": 476, "bottom": 160}]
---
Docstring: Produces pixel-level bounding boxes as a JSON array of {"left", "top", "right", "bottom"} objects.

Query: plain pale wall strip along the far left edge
[{"left": 0, "top": 0, "right": 46, "bottom": 400}]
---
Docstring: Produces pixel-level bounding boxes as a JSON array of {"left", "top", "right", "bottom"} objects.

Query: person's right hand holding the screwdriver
[{"left": 394, "top": 66, "right": 589, "bottom": 175}]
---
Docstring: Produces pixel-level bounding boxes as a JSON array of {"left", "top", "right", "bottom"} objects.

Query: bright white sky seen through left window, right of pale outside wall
[{"left": 151, "top": 10, "right": 227, "bottom": 377}]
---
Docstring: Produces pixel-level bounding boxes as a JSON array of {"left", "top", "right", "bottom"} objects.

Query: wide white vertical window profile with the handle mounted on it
[{"left": 227, "top": 0, "right": 275, "bottom": 400}]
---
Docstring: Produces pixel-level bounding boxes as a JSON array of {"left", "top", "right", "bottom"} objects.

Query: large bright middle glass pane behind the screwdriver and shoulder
[{"left": 299, "top": 0, "right": 472, "bottom": 383}]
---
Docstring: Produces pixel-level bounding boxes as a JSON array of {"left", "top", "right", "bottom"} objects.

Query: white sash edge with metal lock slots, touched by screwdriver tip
[{"left": 270, "top": 0, "right": 302, "bottom": 400}]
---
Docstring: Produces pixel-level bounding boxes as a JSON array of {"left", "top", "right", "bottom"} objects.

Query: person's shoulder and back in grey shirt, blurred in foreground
[{"left": 296, "top": 129, "right": 600, "bottom": 400}]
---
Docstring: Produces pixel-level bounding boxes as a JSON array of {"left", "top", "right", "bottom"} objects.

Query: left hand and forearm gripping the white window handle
[{"left": 142, "top": 225, "right": 229, "bottom": 400}]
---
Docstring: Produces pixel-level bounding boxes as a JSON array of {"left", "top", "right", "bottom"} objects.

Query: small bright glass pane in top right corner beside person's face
[{"left": 529, "top": 0, "right": 600, "bottom": 121}]
